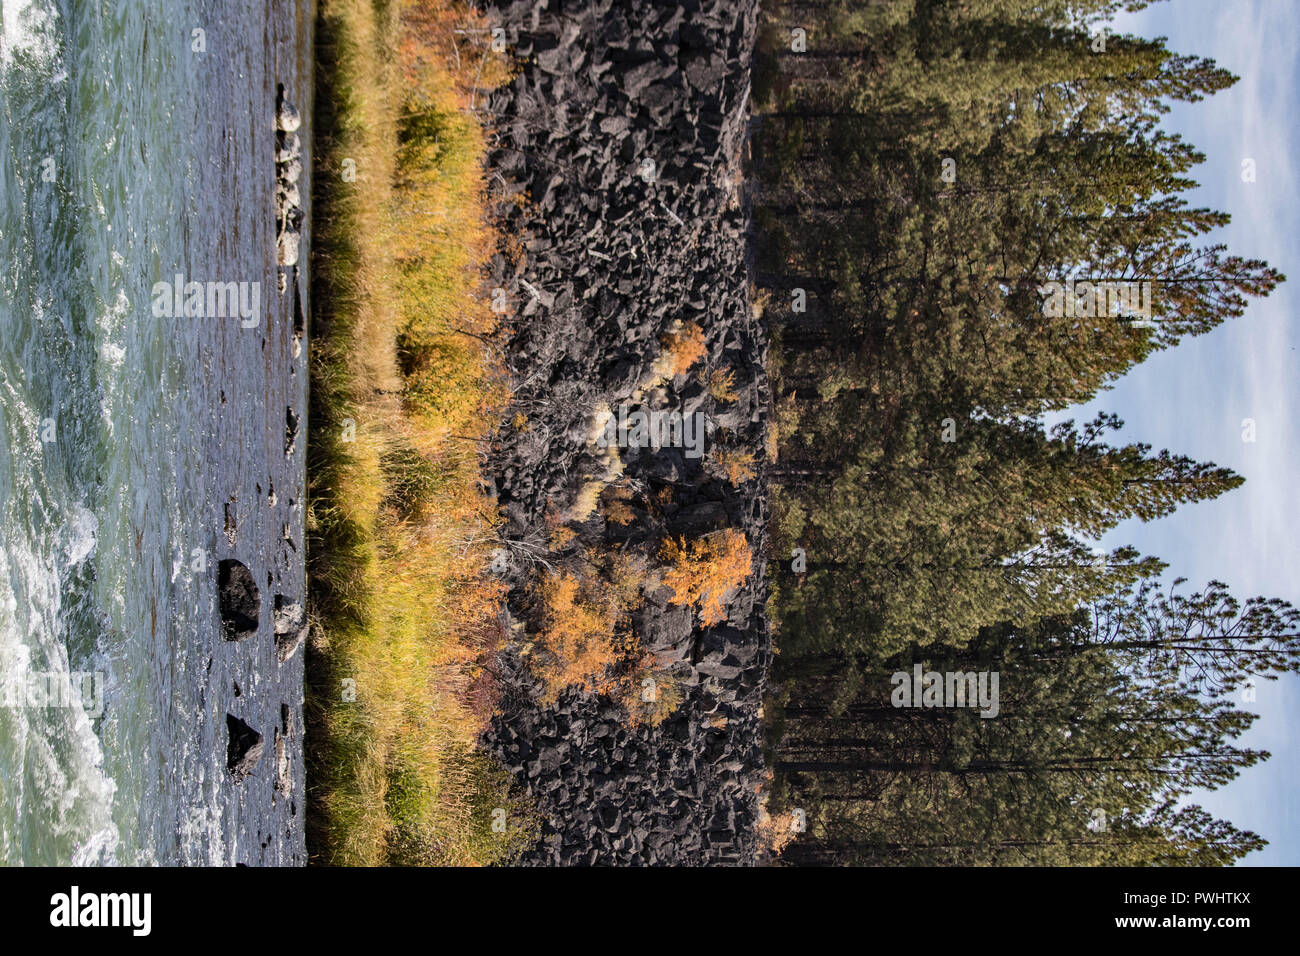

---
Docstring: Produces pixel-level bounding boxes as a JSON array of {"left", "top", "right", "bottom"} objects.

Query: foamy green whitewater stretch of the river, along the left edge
[{"left": 0, "top": 0, "right": 175, "bottom": 865}]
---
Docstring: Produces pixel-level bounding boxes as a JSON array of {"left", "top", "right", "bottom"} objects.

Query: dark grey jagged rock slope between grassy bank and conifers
[{"left": 485, "top": 0, "right": 771, "bottom": 865}]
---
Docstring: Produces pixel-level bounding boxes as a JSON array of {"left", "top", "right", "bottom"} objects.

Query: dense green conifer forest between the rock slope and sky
[{"left": 753, "top": 0, "right": 1300, "bottom": 865}]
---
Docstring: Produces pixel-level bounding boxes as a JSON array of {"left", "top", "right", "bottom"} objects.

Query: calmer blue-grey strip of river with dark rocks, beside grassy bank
[{"left": 175, "top": 3, "right": 315, "bottom": 866}]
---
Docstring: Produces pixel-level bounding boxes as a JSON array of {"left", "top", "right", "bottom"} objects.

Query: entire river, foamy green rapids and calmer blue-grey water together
[{"left": 0, "top": 0, "right": 312, "bottom": 865}]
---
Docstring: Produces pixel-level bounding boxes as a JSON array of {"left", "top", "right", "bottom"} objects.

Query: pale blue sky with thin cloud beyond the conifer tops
[{"left": 1053, "top": 0, "right": 1300, "bottom": 866}]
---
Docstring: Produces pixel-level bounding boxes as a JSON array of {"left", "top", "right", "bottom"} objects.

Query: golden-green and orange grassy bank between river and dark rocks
[{"left": 307, "top": 0, "right": 529, "bottom": 865}]
